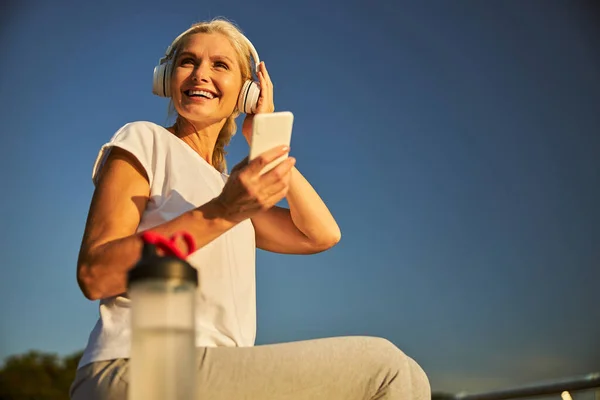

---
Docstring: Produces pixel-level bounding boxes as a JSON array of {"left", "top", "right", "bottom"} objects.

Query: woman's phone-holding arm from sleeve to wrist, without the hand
[{"left": 77, "top": 148, "right": 235, "bottom": 300}]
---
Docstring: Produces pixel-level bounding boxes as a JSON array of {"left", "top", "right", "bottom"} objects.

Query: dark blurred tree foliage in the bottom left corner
[{"left": 0, "top": 350, "right": 83, "bottom": 400}]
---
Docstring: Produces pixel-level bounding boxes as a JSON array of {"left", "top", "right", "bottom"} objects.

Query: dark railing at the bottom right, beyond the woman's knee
[{"left": 432, "top": 373, "right": 600, "bottom": 400}]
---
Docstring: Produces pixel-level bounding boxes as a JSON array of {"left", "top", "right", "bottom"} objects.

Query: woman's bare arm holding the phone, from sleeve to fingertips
[{"left": 77, "top": 148, "right": 292, "bottom": 300}]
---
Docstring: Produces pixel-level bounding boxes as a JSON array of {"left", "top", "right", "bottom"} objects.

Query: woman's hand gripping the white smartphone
[{"left": 217, "top": 146, "right": 296, "bottom": 222}]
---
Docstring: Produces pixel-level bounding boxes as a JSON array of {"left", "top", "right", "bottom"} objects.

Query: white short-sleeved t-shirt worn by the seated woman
[{"left": 79, "top": 121, "right": 256, "bottom": 367}]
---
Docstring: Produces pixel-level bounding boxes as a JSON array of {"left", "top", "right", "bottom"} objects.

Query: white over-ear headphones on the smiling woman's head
[{"left": 152, "top": 27, "right": 260, "bottom": 114}]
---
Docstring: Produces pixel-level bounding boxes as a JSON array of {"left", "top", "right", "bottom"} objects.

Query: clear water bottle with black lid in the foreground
[{"left": 127, "top": 233, "right": 198, "bottom": 400}]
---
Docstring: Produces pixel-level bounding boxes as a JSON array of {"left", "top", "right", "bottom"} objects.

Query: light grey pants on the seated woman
[{"left": 71, "top": 336, "right": 431, "bottom": 400}]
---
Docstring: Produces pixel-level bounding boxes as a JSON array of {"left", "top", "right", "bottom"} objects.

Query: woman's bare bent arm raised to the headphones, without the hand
[{"left": 252, "top": 167, "right": 341, "bottom": 254}]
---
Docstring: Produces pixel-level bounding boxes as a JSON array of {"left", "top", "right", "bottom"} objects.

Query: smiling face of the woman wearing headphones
[{"left": 171, "top": 33, "right": 242, "bottom": 124}]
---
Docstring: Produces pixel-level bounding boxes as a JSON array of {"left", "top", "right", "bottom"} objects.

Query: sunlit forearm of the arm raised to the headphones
[{"left": 286, "top": 167, "right": 341, "bottom": 246}]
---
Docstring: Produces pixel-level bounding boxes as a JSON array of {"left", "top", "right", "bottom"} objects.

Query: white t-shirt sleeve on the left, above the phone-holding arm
[{"left": 92, "top": 123, "right": 155, "bottom": 185}]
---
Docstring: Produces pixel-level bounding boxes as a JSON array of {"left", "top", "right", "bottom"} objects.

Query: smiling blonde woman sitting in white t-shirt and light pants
[{"left": 71, "top": 20, "right": 430, "bottom": 400}]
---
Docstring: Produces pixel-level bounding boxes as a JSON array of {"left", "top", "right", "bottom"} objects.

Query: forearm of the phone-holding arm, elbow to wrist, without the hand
[{"left": 78, "top": 200, "right": 235, "bottom": 300}]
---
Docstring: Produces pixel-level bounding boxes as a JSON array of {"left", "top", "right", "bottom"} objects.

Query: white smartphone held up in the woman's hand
[{"left": 248, "top": 111, "right": 294, "bottom": 175}]
